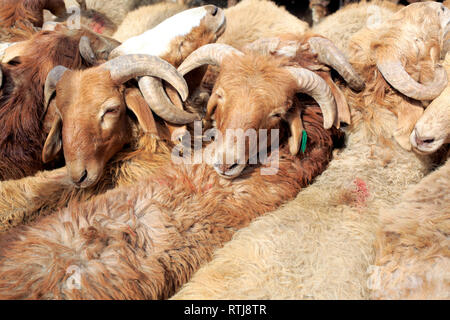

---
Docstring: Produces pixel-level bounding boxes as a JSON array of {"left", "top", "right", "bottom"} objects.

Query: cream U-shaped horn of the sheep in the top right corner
[{"left": 377, "top": 55, "right": 448, "bottom": 100}]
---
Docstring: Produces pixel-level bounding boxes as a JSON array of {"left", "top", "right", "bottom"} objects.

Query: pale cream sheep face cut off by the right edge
[{"left": 410, "top": 54, "right": 450, "bottom": 154}]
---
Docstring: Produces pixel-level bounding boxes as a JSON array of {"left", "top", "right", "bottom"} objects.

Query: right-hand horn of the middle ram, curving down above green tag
[{"left": 285, "top": 67, "right": 337, "bottom": 129}]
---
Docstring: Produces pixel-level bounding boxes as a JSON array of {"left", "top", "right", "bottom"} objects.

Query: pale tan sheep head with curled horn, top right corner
[{"left": 355, "top": 1, "right": 450, "bottom": 101}]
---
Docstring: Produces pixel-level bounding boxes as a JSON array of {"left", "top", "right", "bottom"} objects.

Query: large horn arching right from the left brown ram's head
[{"left": 102, "top": 54, "right": 189, "bottom": 101}]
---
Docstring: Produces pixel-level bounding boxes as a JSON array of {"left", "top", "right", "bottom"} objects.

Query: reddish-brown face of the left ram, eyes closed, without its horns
[{"left": 46, "top": 68, "right": 130, "bottom": 188}]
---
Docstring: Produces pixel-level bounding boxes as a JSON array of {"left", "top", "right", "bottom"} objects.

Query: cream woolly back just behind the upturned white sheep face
[{"left": 113, "top": 2, "right": 188, "bottom": 42}]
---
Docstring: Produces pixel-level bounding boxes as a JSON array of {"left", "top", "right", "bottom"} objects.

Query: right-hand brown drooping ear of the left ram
[{"left": 125, "top": 88, "right": 159, "bottom": 136}]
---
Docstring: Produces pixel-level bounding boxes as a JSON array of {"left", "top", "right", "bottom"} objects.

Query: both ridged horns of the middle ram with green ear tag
[{"left": 178, "top": 44, "right": 337, "bottom": 129}]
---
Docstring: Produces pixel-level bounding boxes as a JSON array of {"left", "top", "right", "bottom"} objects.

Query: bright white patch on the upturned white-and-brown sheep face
[{"left": 115, "top": 7, "right": 207, "bottom": 57}]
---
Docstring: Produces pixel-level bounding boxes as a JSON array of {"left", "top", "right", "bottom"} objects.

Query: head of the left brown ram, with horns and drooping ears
[{"left": 42, "top": 55, "right": 193, "bottom": 188}]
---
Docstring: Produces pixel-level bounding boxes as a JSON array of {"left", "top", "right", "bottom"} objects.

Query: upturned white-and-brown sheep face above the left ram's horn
[{"left": 111, "top": 5, "right": 226, "bottom": 66}]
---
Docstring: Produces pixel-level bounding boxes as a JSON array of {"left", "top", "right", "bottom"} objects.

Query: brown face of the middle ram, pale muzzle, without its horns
[{"left": 207, "top": 55, "right": 296, "bottom": 179}]
